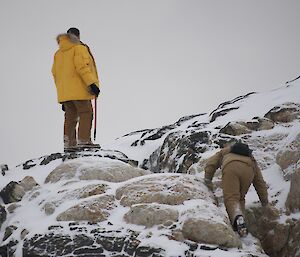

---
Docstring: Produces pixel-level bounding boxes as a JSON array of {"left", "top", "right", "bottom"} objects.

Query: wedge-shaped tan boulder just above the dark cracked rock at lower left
[{"left": 56, "top": 195, "right": 116, "bottom": 222}]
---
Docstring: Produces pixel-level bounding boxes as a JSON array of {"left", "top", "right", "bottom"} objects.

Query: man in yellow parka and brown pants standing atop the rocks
[{"left": 52, "top": 28, "right": 100, "bottom": 152}]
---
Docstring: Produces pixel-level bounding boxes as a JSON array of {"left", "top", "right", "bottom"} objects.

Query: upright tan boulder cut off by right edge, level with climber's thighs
[{"left": 285, "top": 169, "right": 300, "bottom": 212}]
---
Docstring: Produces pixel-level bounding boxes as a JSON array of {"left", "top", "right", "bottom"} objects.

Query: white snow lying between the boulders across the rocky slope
[{"left": 0, "top": 81, "right": 300, "bottom": 257}]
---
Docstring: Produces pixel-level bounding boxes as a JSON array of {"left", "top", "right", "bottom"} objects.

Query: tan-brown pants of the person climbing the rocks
[{"left": 222, "top": 161, "right": 254, "bottom": 224}]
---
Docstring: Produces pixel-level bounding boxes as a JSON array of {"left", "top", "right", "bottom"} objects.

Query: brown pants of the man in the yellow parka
[{"left": 63, "top": 100, "right": 93, "bottom": 148}]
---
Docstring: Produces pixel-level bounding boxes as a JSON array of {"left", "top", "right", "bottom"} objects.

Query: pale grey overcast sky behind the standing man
[{"left": 0, "top": 0, "right": 300, "bottom": 164}]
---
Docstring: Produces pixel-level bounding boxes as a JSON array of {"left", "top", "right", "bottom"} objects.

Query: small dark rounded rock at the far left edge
[{"left": 0, "top": 181, "right": 25, "bottom": 204}]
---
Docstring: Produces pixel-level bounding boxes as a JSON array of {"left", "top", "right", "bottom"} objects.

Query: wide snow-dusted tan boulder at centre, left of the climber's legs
[{"left": 116, "top": 174, "right": 215, "bottom": 206}]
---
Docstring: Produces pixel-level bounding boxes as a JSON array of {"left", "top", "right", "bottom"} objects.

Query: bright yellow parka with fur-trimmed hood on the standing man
[{"left": 52, "top": 34, "right": 99, "bottom": 103}]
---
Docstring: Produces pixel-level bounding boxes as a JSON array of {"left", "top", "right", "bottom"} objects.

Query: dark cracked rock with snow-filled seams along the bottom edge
[{"left": 23, "top": 229, "right": 164, "bottom": 257}]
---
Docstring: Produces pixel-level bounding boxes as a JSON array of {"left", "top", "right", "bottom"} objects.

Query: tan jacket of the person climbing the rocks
[{"left": 205, "top": 147, "right": 268, "bottom": 205}]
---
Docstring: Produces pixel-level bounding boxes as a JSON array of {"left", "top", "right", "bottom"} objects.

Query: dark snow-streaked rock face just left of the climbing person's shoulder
[{"left": 142, "top": 131, "right": 210, "bottom": 173}]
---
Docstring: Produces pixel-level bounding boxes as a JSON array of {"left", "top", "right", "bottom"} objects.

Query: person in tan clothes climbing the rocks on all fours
[{"left": 205, "top": 142, "right": 268, "bottom": 236}]
